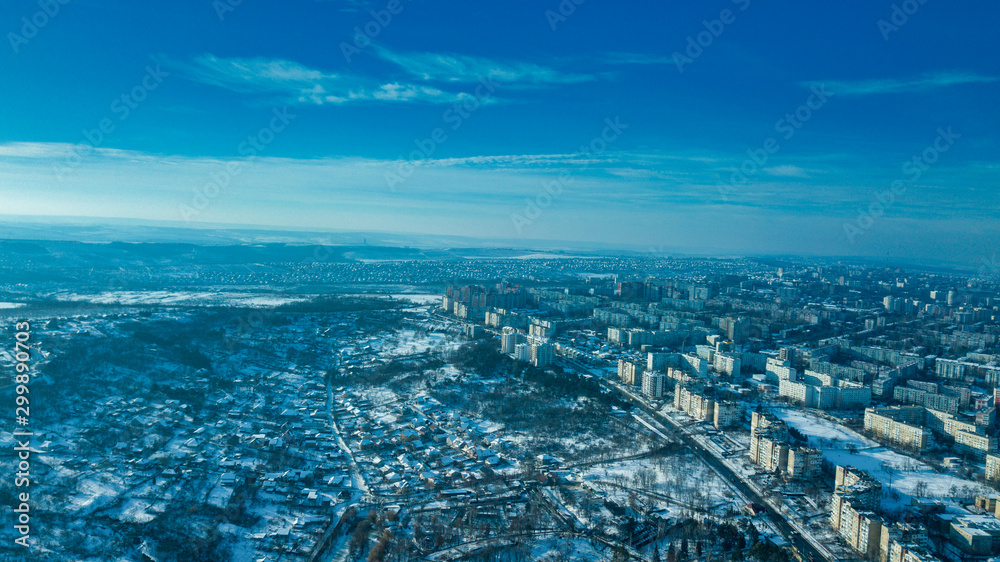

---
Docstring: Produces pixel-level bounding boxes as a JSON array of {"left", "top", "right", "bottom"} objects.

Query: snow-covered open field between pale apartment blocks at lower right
[{"left": 773, "top": 409, "right": 992, "bottom": 509}]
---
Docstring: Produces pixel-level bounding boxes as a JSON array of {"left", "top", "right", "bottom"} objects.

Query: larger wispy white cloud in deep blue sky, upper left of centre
[{"left": 159, "top": 54, "right": 469, "bottom": 105}]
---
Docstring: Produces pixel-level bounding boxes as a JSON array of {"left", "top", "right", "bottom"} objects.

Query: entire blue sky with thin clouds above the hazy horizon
[{"left": 0, "top": 0, "right": 1000, "bottom": 263}]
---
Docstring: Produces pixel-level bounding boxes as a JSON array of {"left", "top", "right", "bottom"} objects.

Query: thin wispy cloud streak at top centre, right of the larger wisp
[{"left": 373, "top": 46, "right": 596, "bottom": 87}]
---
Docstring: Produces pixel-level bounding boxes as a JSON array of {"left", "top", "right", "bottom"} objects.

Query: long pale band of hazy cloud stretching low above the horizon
[{"left": 0, "top": 143, "right": 996, "bottom": 246}]
